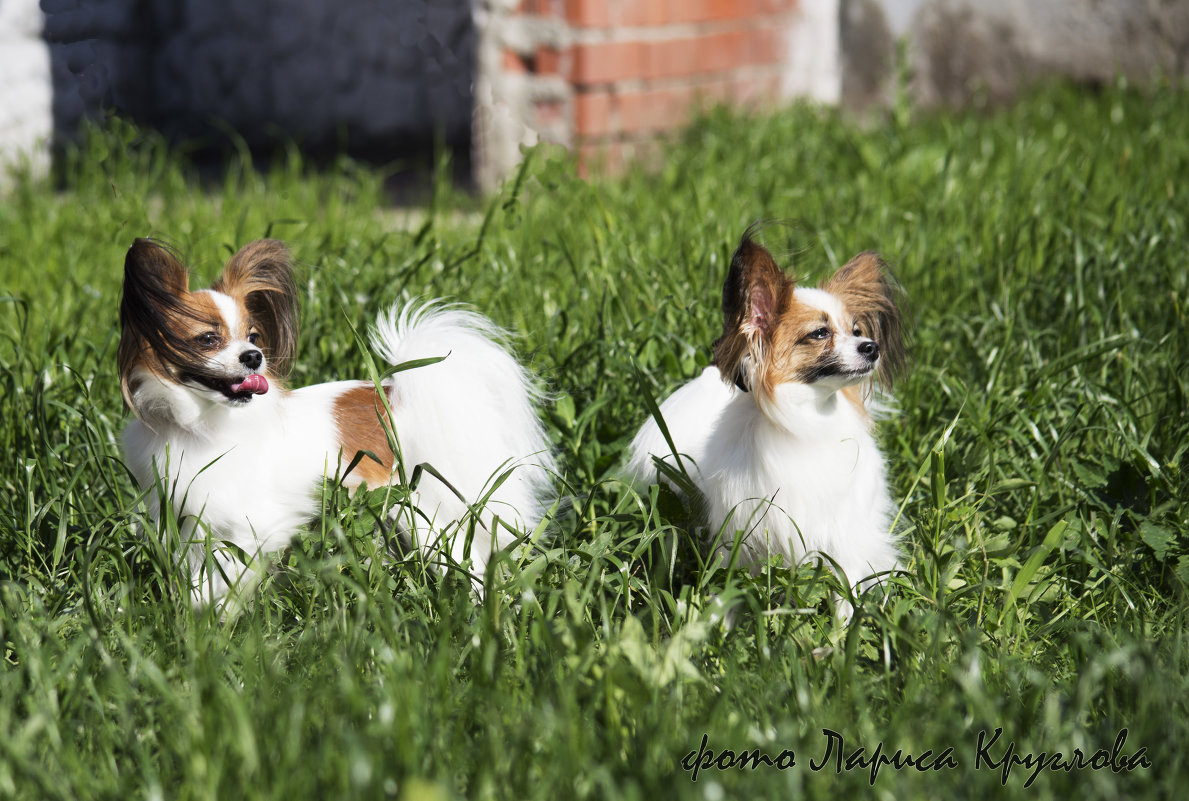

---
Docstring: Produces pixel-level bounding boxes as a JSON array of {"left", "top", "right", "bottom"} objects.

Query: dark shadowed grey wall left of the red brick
[{"left": 42, "top": 0, "right": 477, "bottom": 158}]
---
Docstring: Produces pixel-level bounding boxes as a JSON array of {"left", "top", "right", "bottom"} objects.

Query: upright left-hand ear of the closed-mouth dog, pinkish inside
[{"left": 715, "top": 228, "right": 794, "bottom": 391}]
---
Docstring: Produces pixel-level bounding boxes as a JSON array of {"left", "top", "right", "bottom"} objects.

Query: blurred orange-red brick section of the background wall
[{"left": 504, "top": 0, "right": 798, "bottom": 170}]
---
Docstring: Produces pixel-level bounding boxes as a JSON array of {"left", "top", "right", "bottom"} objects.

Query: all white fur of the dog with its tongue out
[{"left": 124, "top": 298, "right": 554, "bottom": 603}]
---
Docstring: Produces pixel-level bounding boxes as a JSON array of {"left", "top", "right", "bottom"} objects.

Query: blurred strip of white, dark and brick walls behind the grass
[{"left": 0, "top": 0, "right": 1189, "bottom": 189}]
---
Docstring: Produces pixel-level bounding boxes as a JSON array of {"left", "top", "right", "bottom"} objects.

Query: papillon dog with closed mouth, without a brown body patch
[{"left": 628, "top": 229, "right": 905, "bottom": 618}]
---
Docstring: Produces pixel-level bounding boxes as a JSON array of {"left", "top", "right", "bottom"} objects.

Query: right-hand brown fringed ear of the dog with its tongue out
[{"left": 217, "top": 239, "right": 297, "bottom": 376}]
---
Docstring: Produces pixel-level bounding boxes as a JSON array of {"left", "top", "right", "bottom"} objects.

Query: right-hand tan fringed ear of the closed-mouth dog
[{"left": 824, "top": 251, "right": 908, "bottom": 390}]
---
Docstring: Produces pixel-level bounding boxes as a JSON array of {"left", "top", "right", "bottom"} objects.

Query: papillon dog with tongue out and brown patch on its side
[{"left": 119, "top": 239, "right": 554, "bottom": 604}]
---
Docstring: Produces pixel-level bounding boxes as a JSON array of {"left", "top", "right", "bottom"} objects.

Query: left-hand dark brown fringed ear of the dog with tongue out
[{"left": 117, "top": 239, "right": 194, "bottom": 410}]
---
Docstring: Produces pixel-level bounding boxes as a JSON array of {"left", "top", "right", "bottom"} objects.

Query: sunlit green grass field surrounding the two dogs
[{"left": 0, "top": 87, "right": 1189, "bottom": 801}]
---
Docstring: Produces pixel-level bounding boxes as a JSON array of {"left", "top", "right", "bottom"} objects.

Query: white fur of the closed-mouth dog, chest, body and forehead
[{"left": 627, "top": 289, "right": 898, "bottom": 601}]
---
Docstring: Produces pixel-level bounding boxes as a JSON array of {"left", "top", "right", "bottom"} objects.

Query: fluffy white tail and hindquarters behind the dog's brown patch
[{"left": 372, "top": 301, "right": 555, "bottom": 574}]
